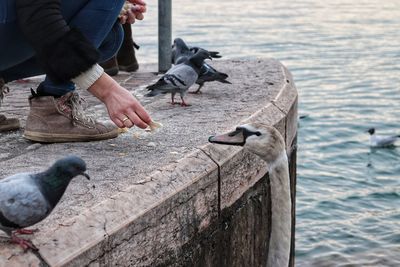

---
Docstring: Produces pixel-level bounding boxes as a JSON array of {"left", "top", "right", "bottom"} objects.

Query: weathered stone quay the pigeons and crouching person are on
[{"left": 0, "top": 60, "right": 297, "bottom": 266}]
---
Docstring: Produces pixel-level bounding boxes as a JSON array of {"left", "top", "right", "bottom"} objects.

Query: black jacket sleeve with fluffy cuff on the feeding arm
[{"left": 15, "top": 0, "right": 99, "bottom": 82}]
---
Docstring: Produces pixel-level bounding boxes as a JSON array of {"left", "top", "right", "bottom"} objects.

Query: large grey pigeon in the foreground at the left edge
[{"left": 0, "top": 156, "right": 90, "bottom": 250}]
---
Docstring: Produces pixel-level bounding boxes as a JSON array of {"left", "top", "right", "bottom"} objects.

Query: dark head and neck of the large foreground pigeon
[{"left": 35, "top": 156, "right": 90, "bottom": 207}]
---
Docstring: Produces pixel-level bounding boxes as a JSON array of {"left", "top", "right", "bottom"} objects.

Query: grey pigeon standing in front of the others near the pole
[{"left": 145, "top": 49, "right": 211, "bottom": 106}]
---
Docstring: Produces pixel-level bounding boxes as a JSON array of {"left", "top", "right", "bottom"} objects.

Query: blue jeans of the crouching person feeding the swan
[{"left": 0, "top": 0, "right": 125, "bottom": 96}]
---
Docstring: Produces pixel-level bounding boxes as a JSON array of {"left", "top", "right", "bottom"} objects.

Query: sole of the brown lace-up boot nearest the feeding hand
[{"left": 24, "top": 129, "right": 118, "bottom": 143}]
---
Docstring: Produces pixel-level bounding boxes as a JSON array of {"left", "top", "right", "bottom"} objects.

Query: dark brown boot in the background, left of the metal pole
[{"left": 117, "top": 23, "right": 139, "bottom": 72}]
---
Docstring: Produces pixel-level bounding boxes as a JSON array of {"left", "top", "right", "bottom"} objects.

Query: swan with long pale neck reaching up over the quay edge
[{"left": 209, "top": 123, "right": 292, "bottom": 267}]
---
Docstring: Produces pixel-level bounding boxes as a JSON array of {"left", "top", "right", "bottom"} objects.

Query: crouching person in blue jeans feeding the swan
[{"left": 0, "top": 0, "right": 151, "bottom": 142}]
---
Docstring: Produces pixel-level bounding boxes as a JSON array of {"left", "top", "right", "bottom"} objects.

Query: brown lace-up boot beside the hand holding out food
[{"left": 24, "top": 92, "right": 118, "bottom": 143}]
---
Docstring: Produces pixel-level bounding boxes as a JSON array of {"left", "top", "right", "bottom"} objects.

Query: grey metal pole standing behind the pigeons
[{"left": 158, "top": 0, "right": 172, "bottom": 72}]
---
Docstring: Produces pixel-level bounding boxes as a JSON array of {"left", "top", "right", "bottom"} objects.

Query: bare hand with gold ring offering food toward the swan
[{"left": 88, "top": 73, "right": 151, "bottom": 129}]
